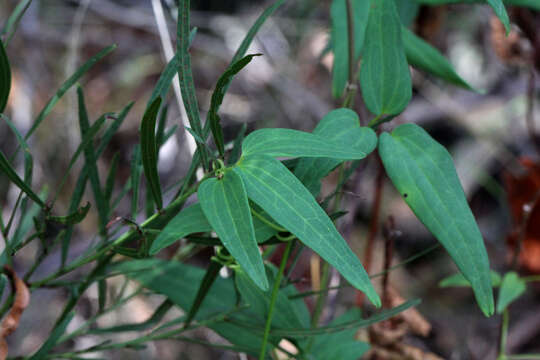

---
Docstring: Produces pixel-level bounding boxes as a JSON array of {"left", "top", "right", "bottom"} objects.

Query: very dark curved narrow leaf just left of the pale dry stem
[{"left": 140, "top": 98, "right": 163, "bottom": 210}]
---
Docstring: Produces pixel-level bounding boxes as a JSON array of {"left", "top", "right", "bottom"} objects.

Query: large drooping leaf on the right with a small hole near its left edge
[{"left": 379, "top": 124, "right": 494, "bottom": 316}]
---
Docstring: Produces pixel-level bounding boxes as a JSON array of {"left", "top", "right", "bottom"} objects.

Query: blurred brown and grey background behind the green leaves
[{"left": 0, "top": 0, "right": 540, "bottom": 359}]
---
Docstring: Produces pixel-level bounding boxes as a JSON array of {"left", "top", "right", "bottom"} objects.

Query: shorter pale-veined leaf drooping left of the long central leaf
[{"left": 197, "top": 170, "right": 268, "bottom": 290}]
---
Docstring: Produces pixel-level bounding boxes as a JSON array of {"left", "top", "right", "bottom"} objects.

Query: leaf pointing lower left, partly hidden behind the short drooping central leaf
[{"left": 150, "top": 203, "right": 277, "bottom": 255}]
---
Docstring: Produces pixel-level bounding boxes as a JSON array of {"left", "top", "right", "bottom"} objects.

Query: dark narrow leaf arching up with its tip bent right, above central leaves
[{"left": 206, "top": 54, "right": 262, "bottom": 157}]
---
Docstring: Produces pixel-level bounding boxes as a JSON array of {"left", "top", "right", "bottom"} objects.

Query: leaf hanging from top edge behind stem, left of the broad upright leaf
[{"left": 330, "top": 0, "right": 371, "bottom": 98}]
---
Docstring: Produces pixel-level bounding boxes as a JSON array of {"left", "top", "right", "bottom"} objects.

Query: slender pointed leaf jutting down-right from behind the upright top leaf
[{"left": 401, "top": 27, "right": 475, "bottom": 91}]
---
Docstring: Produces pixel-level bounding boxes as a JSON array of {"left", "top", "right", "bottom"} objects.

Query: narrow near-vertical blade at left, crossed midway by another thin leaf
[{"left": 77, "top": 86, "right": 109, "bottom": 234}]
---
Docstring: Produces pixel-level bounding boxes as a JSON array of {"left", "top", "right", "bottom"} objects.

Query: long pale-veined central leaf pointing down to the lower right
[{"left": 234, "top": 155, "right": 380, "bottom": 306}]
